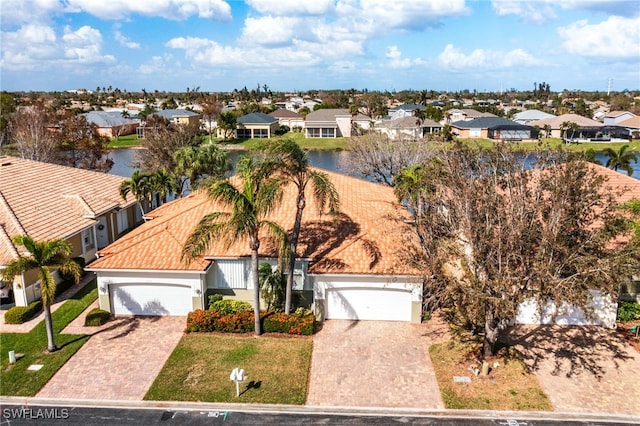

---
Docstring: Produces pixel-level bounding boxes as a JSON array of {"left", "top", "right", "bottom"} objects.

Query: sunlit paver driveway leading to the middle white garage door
[{"left": 307, "top": 320, "right": 446, "bottom": 408}]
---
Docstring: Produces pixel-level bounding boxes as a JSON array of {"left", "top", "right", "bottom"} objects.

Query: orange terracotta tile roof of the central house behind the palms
[{"left": 91, "top": 170, "right": 417, "bottom": 274}]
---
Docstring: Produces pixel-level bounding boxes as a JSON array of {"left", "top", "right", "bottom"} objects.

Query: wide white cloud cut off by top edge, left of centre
[{"left": 66, "top": 0, "right": 231, "bottom": 21}]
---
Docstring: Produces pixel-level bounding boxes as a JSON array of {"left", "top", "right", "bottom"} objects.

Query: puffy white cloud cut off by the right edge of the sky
[{"left": 558, "top": 16, "right": 640, "bottom": 58}]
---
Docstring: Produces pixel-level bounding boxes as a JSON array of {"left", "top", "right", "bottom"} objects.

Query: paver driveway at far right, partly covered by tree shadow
[{"left": 505, "top": 326, "right": 640, "bottom": 415}]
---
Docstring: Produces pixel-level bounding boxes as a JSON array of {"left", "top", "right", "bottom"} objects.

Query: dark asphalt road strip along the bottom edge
[{"left": 0, "top": 405, "right": 632, "bottom": 426}]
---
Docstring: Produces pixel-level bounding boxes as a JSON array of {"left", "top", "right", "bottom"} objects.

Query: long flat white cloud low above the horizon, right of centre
[{"left": 438, "top": 44, "right": 542, "bottom": 70}]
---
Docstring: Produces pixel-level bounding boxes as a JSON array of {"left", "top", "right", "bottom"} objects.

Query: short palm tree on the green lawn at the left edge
[{"left": 3, "top": 235, "right": 82, "bottom": 352}]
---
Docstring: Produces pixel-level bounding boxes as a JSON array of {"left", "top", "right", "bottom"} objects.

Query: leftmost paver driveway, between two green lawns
[{"left": 37, "top": 306, "right": 186, "bottom": 400}]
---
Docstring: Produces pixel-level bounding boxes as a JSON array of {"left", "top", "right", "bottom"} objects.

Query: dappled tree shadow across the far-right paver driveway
[{"left": 500, "top": 325, "right": 636, "bottom": 380}]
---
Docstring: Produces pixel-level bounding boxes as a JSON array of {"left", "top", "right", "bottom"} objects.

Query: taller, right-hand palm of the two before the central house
[{"left": 262, "top": 139, "right": 340, "bottom": 314}]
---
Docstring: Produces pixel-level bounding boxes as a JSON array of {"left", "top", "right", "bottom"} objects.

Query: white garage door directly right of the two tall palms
[{"left": 326, "top": 287, "right": 411, "bottom": 321}]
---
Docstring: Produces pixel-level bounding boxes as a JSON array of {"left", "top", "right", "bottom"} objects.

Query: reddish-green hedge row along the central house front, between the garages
[{"left": 187, "top": 309, "right": 315, "bottom": 336}]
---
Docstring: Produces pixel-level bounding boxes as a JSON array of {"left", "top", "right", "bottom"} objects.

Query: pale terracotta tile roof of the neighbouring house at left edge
[{"left": 0, "top": 156, "right": 135, "bottom": 264}]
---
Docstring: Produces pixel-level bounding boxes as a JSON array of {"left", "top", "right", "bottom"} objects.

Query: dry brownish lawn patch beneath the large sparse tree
[{"left": 429, "top": 340, "right": 553, "bottom": 411}]
